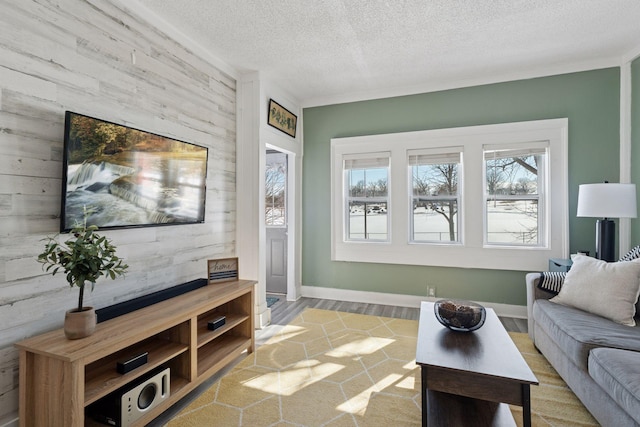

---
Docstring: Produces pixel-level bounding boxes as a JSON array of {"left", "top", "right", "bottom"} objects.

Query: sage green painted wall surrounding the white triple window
[{"left": 302, "top": 68, "right": 620, "bottom": 305}]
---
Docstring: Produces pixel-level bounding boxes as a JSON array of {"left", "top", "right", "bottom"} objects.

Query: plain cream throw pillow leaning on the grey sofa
[{"left": 551, "top": 255, "right": 640, "bottom": 326}]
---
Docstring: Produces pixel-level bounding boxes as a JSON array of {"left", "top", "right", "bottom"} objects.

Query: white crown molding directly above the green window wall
[{"left": 302, "top": 56, "right": 621, "bottom": 108}]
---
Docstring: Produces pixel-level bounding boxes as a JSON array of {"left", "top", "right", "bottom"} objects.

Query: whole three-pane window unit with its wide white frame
[{"left": 331, "top": 119, "right": 569, "bottom": 271}]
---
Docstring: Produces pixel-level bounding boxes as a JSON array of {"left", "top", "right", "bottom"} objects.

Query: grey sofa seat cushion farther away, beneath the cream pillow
[{"left": 533, "top": 299, "right": 640, "bottom": 371}]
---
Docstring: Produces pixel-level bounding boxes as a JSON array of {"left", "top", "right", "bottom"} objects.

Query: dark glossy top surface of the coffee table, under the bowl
[{"left": 416, "top": 301, "right": 538, "bottom": 384}]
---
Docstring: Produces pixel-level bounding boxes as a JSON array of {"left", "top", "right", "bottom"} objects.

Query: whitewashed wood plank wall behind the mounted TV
[{"left": 0, "top": 0, "right": 236, "bottom": 425}]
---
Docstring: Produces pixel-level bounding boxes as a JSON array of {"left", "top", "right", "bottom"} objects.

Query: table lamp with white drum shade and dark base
[{"left": 577, "top": 181, "right": 638, "bottom": 262}]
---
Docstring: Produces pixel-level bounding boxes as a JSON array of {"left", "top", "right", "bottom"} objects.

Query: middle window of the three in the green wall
[{"left": 408, "top": 147, "right": 462, "bottom": 243}]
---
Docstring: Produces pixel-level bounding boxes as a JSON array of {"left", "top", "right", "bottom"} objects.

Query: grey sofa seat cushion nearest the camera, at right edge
[{"left": 589, "top": 348, "right": 640, "bottom": 424}]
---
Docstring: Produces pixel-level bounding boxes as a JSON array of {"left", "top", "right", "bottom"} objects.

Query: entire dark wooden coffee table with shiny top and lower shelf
[{"left": 416, "top": 301, "right": 538, "bottom": 427}]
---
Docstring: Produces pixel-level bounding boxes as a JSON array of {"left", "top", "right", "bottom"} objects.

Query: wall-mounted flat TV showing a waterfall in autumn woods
[{"left": 60, "top": 111, "right": 207, "bottom": 231}]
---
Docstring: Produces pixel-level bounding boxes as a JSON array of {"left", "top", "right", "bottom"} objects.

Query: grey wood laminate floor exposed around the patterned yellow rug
[{"left": 158, "top": 294, "right": 527, "bottom": 426}]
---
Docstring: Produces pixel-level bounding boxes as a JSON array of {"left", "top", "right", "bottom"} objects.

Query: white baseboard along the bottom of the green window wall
[{"left": 301, "top": 286, "right": 527, "bottom": 319}]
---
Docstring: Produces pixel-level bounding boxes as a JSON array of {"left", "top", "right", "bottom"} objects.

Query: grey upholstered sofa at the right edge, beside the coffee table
[{"left": 526, "top": 273, "right": 640, "bottom": 427}]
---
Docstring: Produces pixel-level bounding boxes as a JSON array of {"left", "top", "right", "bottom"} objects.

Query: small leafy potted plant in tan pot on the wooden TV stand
[{"left": 38, "top": 207, "right": 129, "bottom": 339}]
